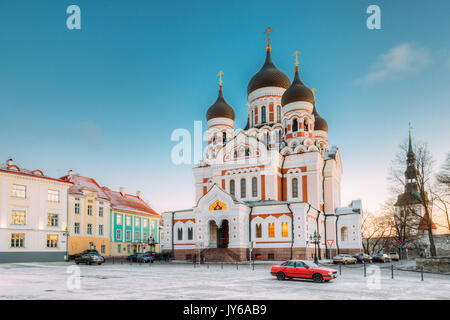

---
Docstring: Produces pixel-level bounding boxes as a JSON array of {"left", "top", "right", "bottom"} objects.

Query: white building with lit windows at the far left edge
[{"left": 0, "top": 159, "right": 71, "bottom": 262}]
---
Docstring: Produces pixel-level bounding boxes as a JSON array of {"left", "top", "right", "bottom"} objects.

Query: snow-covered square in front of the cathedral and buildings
[{"left": 0, "top": 262, "right": 450, "bottom": 300}]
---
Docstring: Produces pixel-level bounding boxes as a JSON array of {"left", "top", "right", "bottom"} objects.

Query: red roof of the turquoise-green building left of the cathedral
[{"left": 103, "top": 187, "right": 161, "bottom": 217}]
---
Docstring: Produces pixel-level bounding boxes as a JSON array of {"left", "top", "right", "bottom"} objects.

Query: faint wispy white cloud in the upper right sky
[{"left": 354, "top": 43, "right": 430, "bottom": 85}]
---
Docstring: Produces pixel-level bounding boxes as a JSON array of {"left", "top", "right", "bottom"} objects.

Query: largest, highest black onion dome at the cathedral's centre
[{"left": 247, "top": 50, "right": 291, "bottom": 94}]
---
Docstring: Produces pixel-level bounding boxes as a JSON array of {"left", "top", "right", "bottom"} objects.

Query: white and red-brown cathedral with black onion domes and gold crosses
[{"left": 161, "top": 30, "right": 362, "bottom": 261}]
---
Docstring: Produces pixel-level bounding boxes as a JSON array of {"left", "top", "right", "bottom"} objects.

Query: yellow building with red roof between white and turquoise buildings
[{"left": 61, "top": 171, "right": 110, "bottom": 256}]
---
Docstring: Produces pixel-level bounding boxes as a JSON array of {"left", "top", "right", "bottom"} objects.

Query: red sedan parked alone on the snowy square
[{"left": 270, "top": 260, "right": 337, "bottom": 282}]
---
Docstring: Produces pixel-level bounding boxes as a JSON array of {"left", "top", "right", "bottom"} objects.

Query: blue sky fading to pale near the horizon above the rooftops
[{"left": 0, "top": 0, "right": 450, "bottom": 211}]
